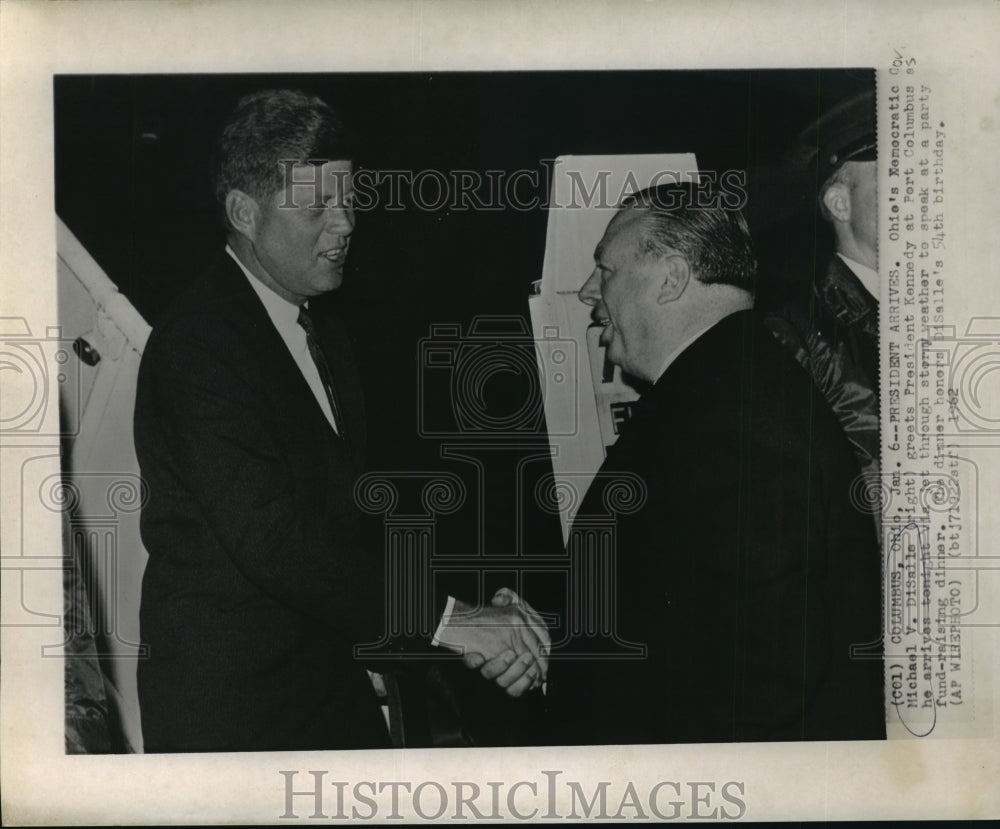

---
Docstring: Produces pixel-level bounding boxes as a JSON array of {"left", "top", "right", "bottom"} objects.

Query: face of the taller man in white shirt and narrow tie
[{"left": 249, "top": 161, "right": 354, "bottom": 305}]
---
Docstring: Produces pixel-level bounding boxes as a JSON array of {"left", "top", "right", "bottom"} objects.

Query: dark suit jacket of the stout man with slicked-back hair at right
[{"left": 549, "top": 312, "right": 885, "bottom": 743}]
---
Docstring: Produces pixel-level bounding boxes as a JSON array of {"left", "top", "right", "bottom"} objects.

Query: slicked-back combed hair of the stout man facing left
[{"left": 622, "top": 181, "right": 757, "bottom": 293}]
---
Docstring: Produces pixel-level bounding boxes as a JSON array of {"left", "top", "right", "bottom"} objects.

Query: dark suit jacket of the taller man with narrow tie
[{"left": 135, "top": 256, "right": 389, "bottom": 752}]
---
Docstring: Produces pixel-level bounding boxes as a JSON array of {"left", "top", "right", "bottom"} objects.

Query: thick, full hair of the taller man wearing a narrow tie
[{"left": 214, "top": 89, "right": 352, "bottom": 223}]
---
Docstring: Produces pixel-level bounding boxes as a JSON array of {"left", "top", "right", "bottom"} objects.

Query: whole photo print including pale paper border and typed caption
[{"left": 0, "top": 3, "right": 1000, "bottom": 825}]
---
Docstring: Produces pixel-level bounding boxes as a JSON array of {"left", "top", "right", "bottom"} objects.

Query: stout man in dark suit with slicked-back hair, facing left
[{"left": 549, "top": 184, "right": 885, "bottom": 743}]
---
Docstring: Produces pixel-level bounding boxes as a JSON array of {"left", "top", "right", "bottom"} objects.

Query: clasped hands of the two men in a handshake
[{"left": 437, "top": 587, "right": 552, "bottom": 697}]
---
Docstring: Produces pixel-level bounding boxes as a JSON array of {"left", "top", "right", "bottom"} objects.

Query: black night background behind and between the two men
[{"left": 54, "top": 69, "right": 874, "bottom": 743}]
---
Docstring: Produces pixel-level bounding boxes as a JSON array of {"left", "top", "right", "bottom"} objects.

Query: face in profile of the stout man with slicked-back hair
[{"left": 579, "top": 208, "right": 663, "bottom": 382}]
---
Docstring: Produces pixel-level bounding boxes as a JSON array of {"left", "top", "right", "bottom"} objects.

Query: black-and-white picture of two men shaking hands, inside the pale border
[{"left": 54, "top": 68, "right": 885, "bottom": 752}]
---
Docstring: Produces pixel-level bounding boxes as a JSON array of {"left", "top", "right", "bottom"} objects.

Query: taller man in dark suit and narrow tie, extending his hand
[{"left": 135, "top": 90, "right": 546, "bottom": 752}]
